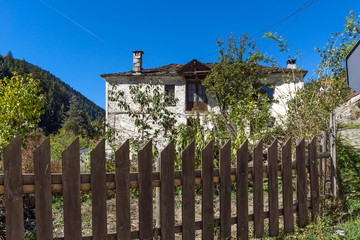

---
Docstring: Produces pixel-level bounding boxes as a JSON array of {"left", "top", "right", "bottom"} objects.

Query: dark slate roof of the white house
[{"left": 100, "top": 59, "right": 308, "bottom": 78}]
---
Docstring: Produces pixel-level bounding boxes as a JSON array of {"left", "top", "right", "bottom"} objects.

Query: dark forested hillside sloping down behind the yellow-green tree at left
[{"left": 0, "top": 52, "right": 105, "bottom": 135}]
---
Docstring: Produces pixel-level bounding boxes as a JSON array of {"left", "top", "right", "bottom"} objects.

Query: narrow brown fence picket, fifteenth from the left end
[{"left": 296, "top": 139, "right": 308, "bottom": 228}]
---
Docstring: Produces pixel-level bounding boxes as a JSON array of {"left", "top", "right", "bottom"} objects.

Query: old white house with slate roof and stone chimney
[{"left": 101, "top": 51, "right": 307, "bottom": 145}]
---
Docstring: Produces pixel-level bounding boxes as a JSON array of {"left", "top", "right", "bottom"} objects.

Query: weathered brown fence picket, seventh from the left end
[{"left": 160, "top": 141, "right": 175, "bottom": 240}]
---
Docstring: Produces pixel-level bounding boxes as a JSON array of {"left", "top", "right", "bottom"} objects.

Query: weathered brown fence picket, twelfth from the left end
[{"left": 253, "top": 140, "right": 264, "bottom": 238}]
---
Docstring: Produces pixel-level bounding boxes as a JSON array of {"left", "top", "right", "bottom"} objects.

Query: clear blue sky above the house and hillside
[{"left": 0, "top": 0, "right": 360, "bottom": 108}]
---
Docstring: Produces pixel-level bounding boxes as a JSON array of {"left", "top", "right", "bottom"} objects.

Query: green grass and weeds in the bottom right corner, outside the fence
[{"left": 264, "top": 137, "right": 360, "bottom": 240}]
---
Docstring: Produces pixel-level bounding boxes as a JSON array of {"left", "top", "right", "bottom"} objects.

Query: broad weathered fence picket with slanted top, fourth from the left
[{"left": 90, "top": 139, "right": 107, "bottom": 239}]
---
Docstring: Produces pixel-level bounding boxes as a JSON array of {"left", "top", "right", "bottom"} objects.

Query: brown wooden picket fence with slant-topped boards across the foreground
[{"left": 0, "top": 136, "right": 330, "bottom": 240}]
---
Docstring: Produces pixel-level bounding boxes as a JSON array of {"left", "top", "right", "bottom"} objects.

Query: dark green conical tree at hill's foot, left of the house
[{"left": 63, "top": 97, "right": 93, "bottom": 138}]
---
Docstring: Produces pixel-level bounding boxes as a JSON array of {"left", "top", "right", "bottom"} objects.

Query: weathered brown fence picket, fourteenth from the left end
[{"left": 281, "top": 138, "right": 294, "bottom": 233}]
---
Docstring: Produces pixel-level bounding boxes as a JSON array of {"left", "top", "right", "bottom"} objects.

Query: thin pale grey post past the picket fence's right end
[{"left": 329, "top": 113, "right": 337, "bottom": 197}]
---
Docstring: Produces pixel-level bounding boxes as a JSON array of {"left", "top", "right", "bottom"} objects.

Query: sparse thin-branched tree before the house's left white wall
[{"left": 108, "top": 80, "right": 177, "bottom": 154}]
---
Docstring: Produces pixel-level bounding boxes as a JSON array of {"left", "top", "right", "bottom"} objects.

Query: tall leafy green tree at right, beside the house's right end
[{"left": 266, "top": 11, "right": 360, "bottom": 139}]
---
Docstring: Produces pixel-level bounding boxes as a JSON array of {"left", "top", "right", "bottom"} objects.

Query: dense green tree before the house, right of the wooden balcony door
[{"left": 202, "top": 34, "right": 272, "bottom": 143}]
